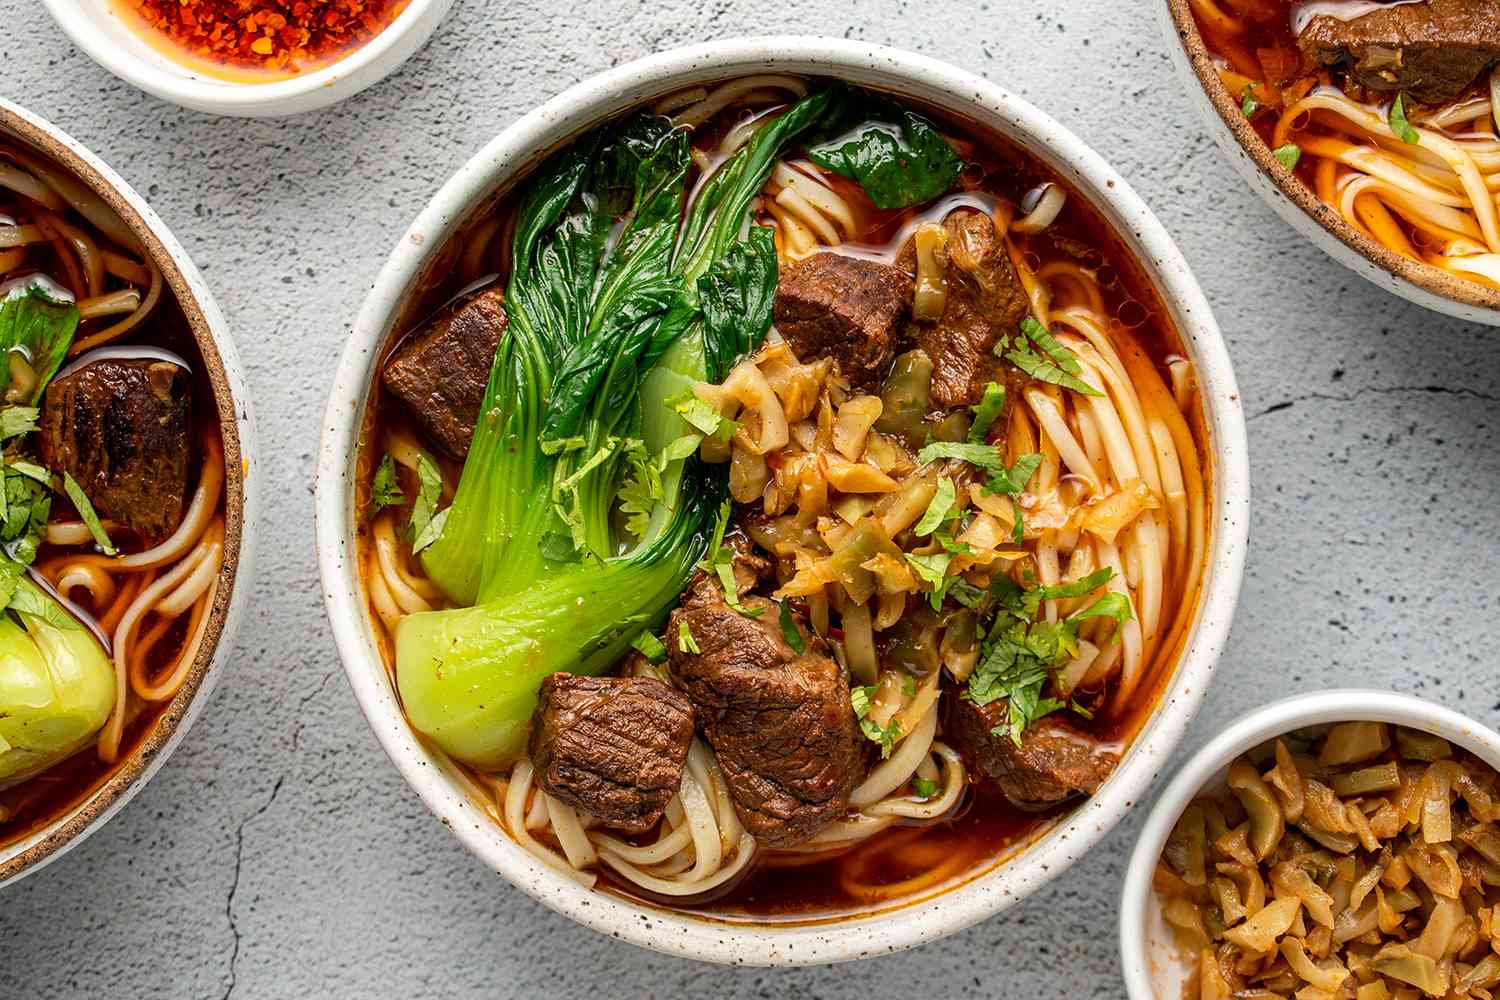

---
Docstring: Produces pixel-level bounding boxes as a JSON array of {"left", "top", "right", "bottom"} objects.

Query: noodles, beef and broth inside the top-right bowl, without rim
[{"left": 1190, "top": 0, "right": 1500, "bottom": 289}]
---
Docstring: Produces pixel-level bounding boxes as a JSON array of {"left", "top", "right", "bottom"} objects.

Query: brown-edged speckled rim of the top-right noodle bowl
[{"left": 1166, "top": 0, "right": 1500, "bottom": 322}]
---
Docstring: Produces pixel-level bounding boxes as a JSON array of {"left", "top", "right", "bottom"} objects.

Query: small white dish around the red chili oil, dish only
[{"left": 42, "top": 0, "right": 453, "bottom": 118}]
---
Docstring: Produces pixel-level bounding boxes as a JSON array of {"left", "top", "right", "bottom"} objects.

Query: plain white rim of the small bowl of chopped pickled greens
[{"left": 1119, "top": 688, "right": 1500, "bottom": 1000}]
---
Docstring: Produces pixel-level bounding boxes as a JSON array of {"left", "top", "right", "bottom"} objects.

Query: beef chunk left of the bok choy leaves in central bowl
[{"left": 383, "top": 288, "right": 506, "bottom": 459}]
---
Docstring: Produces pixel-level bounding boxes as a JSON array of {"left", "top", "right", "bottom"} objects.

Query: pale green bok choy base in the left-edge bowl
[{"left": 0, "top": 569, "right": 116, "bottom": 789}]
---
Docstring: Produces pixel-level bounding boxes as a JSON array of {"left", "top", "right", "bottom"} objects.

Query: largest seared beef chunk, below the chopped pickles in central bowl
[{"left": 668, "top": 587, "right": 864, "bottom": 847}]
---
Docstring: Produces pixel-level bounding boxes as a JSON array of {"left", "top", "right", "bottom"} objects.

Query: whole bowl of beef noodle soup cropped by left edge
[{"left": 0, "top": 100, "right": 255, "bottom": 885}]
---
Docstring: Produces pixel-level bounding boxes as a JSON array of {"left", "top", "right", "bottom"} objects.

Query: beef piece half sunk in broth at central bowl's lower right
[{"left": 942, "top": 688, "right": 1119, "bottom": 810}]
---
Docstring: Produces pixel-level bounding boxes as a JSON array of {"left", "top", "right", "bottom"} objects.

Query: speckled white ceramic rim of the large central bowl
[{"left": 317, "top": 37, "right": 1250, "bottom": 966}]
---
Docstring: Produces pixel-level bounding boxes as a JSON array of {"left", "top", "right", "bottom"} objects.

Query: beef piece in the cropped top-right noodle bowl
[{"left": 1298, "top": 0, "right": 1500, "bottom": 103}]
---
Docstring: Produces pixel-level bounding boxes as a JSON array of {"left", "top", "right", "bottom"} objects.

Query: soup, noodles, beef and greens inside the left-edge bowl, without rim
[{"left": 0, "top": 133, "right": 225, "bottom": 846}]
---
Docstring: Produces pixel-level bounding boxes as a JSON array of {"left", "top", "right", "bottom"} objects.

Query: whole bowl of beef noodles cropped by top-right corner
[{"left": 1160, "top": 0, "right": 1500, "bottom": 325}]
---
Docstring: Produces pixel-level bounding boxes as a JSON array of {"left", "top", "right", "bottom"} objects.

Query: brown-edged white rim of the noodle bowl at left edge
[{"left": 0, "top": 97, "right": 260, "bottom": 886}]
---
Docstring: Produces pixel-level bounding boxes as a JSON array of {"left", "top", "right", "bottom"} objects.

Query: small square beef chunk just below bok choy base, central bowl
[{"left": 530, "top": 673, "right": 693, "bottom": 834}]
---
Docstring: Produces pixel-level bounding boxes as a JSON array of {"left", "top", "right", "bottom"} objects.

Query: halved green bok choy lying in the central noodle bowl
[{"left": 396, "top": 90, "right": 848, "bottom": 766}]
